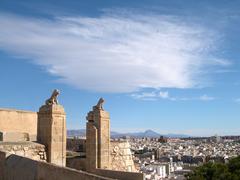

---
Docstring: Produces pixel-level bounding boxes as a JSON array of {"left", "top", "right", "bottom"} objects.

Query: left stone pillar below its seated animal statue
[{"left": 37, "top": 104, "right": 66, "bottom": 166}]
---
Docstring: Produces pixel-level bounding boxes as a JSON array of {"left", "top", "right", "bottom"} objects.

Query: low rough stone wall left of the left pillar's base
[{"left": 0, "top": 142, "right": 46, "bottom": 161}]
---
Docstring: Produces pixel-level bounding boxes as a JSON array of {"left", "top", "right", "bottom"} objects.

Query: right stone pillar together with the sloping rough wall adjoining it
[{"left": 86, "top": 98, "right": 136, "bottom": 176}]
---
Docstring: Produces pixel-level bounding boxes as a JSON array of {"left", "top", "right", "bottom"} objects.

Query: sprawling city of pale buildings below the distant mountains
[{"left": 68, "top": 130, "right": 240, "bottom": 179}]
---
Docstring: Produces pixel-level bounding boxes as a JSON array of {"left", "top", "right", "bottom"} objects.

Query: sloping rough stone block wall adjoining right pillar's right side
[{"left": 110, "top": 141, "right": 136, "bottom": 172}]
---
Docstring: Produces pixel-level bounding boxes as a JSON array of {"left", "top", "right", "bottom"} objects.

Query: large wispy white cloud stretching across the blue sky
[{"left": 0, "top": 13, "right": 229, "bottom": 93}]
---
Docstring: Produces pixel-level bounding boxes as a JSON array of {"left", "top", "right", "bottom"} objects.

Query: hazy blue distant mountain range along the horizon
[{"left": 67, "top": 129, "right": 190, "bottom": 138}]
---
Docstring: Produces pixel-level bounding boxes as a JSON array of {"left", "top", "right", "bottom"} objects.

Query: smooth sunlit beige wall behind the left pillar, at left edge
[{"left": 0, "top": 109, "right": 37, "bottom": 141}]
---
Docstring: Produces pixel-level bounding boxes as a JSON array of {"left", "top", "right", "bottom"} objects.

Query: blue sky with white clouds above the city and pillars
[{"left": 0, "top": 0, "right": 240, "bottom": 136}]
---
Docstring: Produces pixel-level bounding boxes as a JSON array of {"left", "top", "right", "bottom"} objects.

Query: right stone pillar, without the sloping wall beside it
[{"left": 86, "top": 99, "right": 110, "bottom": 171}]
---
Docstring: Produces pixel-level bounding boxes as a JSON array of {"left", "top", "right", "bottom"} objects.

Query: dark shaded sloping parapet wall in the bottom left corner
[{"left": 0, "top": 152, "right": 112, "bottom": 180}]
